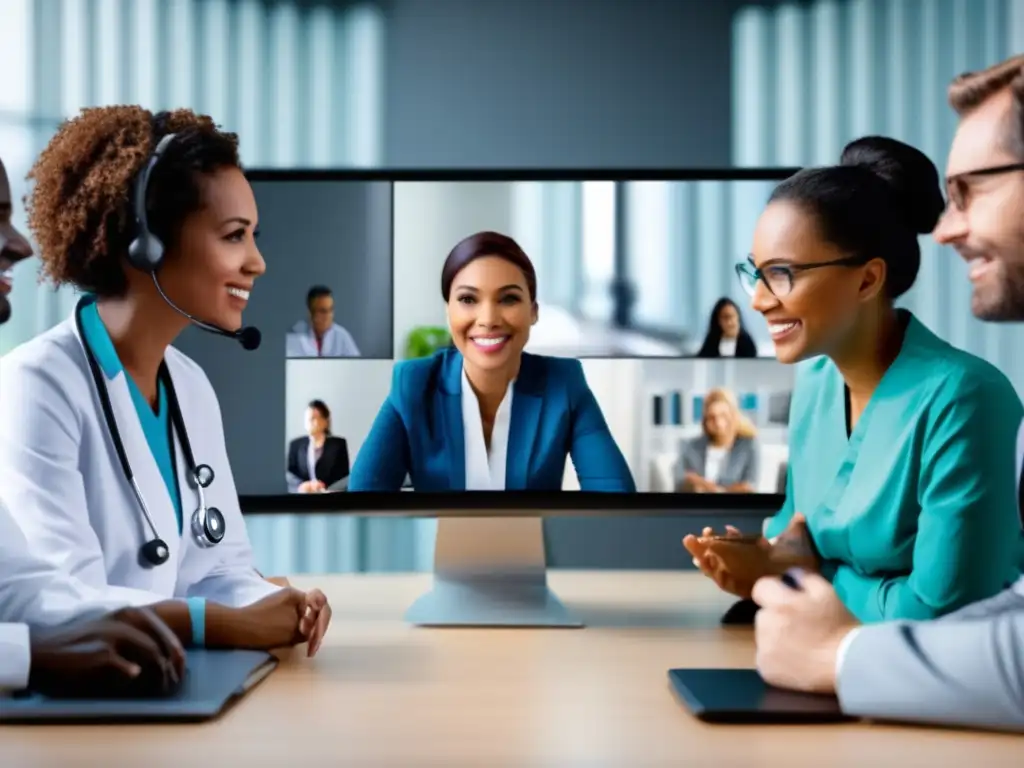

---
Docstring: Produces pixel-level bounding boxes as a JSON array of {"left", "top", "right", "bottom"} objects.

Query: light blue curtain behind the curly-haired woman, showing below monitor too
[{"left": 0, "top": 0, "right": 389, "bottom": 573}]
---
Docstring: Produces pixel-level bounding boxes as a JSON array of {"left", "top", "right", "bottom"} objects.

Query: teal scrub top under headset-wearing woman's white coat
[{"left": 81, "top": 301, "right": 182, "bottom": 536}]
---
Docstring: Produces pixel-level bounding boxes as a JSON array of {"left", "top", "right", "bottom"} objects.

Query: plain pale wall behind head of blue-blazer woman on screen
[{"left": 392, "top": 181, "right": 526, "bottom": 356}]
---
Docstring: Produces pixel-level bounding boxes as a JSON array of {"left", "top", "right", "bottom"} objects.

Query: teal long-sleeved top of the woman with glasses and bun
[{"left": 765, "top": 315, "right": 1024, "bottom": 623}]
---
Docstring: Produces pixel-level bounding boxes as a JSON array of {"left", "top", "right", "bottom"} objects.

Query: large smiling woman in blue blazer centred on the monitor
[{"left": 348, "top": 232, "right": 636, "bottom": 493}]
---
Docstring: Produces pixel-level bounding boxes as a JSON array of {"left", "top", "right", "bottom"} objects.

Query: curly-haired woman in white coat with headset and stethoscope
[{"left": 0, "top": 106, "right": 331, "bottom": 652}]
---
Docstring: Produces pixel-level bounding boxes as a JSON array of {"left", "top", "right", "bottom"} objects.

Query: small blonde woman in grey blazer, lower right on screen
[{"left": 675, "top": 389, "right": 760, "bottom": 494}]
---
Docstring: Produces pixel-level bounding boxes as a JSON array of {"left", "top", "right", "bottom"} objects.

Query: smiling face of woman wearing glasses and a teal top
[{"left": 751, "top": 200, "right": 886, "bottom": 364}]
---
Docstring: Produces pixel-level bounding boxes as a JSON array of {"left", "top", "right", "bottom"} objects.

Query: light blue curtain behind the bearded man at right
[{"left": 732, "top": 0, "right": 1024, "bottom": 391}]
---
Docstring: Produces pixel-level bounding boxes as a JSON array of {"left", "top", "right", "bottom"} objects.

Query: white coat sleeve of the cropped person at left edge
[{"left": 0, "top": 503, "right": 127, "bottom": 691}]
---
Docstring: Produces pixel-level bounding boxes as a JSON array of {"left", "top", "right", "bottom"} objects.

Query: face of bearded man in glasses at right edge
[{"left": 934, "top": 90, "right": 1024, "bottom": 321}]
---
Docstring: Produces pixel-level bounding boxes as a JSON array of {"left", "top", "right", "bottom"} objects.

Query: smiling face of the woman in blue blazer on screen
[{"left": 447, "top": 256, "right": 537, "bottom": 371}]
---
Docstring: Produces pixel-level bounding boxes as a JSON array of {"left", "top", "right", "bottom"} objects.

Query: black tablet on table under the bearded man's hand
[{"left": 669, "top": 670, "right": 850, "bottom": 723}]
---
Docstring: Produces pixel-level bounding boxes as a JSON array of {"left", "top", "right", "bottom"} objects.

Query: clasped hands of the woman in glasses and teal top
[{"left": 683, "top": 512, "right": 821, "bottom": 600}]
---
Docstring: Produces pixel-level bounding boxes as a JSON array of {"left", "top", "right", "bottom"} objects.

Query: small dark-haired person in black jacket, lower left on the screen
[{"left": 288, "top": 400, "right": 348, "bottom": 494}]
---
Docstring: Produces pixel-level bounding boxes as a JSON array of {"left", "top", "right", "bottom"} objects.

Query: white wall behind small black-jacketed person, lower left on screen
[{"left": 282, "top": 358, "right": 394, "bottom": 462}]
